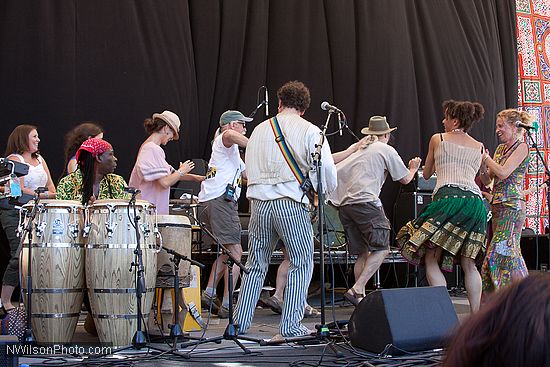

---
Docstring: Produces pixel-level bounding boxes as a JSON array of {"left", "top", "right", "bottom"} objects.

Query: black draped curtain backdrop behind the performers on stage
[{"left": 0, "top": 0, "right": 517, "bottom": 211}]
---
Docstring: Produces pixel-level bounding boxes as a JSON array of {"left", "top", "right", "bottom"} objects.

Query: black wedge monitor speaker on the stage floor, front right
[{"left": 348, "top": 287, "right": 458, "bottom": 354}]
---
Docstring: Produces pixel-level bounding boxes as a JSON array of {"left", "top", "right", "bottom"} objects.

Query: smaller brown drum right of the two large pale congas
[{"left": 156, "top": 215, "right": 191, "bottom": 332}]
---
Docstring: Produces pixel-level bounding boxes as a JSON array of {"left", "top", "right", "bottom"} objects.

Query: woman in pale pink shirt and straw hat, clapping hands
[{"left": 129, "top": 111, "right": 204, "bottom": 214}]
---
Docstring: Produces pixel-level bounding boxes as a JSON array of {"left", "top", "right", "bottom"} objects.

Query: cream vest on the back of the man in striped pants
[{"left": 245, "top": 114, "right": 315, "bottom": 185}]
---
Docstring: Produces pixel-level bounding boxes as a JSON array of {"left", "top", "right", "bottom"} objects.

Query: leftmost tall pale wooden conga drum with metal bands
[{"left": 20, "top": 200, "right": 85, "bottom": 344}]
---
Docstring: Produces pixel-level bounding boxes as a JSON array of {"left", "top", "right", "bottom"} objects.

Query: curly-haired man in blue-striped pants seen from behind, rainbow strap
[{"left": 235, "top": 81, "right": 336, "bottom": 337}]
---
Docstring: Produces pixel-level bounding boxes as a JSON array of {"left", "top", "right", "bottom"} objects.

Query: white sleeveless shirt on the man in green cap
[{"left": 199, "top": 130, "right": 245, "bottom": 203}]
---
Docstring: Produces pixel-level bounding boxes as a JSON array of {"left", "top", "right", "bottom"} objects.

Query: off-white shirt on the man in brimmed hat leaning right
[{"left": 329, "top": 141, "right": 409, "bottom": 206}]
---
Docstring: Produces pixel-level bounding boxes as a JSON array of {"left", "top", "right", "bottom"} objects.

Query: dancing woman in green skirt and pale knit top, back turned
[{"left": 397, "top": 100, "right": 487, "bottom": 312}]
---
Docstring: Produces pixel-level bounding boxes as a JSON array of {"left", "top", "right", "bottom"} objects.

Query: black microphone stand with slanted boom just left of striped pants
[{"left": 180, "top": 218, "right": 263, "bottom": 356}]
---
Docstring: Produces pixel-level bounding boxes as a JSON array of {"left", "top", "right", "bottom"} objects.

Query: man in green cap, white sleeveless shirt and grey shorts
[{"left": 199, "top": 110, "right": 252, "bottom": 318}]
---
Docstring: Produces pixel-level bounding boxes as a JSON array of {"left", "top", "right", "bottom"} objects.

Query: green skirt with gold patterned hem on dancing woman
[{"left": 396, "top": 186, "right": 487, "bottom": 271}]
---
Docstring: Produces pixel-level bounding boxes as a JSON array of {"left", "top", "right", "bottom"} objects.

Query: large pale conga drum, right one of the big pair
[{"left": 86, "top": 200, "right": 157, "bottom": 347}]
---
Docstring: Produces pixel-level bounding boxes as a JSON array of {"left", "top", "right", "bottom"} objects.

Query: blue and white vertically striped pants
[{"left": 235, "top": 199, "right": 313, "bottom": 337}]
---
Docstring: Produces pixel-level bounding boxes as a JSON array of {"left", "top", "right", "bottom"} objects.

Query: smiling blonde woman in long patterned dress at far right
[{"left": 480, "top": 109, "right": 532, "bottom": 293}]
